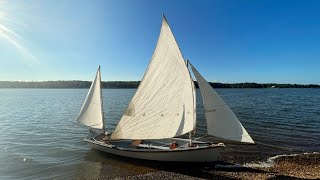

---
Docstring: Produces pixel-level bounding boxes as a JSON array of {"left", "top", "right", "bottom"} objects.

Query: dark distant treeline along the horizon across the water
[{"left": 0, "top": 81, "right": 320, "bottom": 89}]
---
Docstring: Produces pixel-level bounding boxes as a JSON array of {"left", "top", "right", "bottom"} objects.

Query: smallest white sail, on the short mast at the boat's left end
[{"left": 77, "top": 66, "right": 104, "bottom": 129}]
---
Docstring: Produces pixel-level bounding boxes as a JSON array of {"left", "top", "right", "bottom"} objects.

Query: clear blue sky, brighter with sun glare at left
[{"left": 0, "top": 0, "right": 320, "bottom": 84}]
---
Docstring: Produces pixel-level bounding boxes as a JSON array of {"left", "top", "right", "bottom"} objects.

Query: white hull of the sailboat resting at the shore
[{"left": 85, "top": 133, "right": 225, "bottom": 162}]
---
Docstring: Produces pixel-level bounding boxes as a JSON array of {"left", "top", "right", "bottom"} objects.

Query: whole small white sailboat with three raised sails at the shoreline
[{"left": 77, "top": 15, "right": 254, "bottom": 162}]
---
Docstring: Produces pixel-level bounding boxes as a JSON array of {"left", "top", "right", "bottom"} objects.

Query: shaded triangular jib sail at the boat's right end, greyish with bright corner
[{"left": 189, "top": 62, "right": 254, "bottom": 143}]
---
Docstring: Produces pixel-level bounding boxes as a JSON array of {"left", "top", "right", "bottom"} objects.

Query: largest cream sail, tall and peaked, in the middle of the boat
[{"left": 111, "top": 17, "right": 196, "bottom": 139}]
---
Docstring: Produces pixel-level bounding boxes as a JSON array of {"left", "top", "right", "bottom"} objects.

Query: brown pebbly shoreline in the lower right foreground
[{"left": 111, "top": 153, "right": 320, "bottom": 180}]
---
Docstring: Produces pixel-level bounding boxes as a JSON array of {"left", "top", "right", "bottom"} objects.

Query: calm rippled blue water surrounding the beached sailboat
[{"left": 0, "top": 89, "right": 320, "bottom": 179}]
